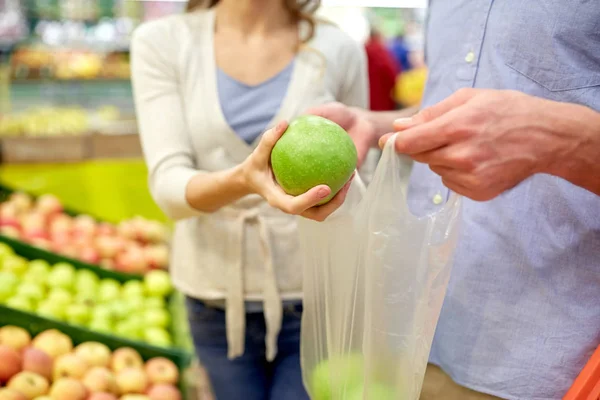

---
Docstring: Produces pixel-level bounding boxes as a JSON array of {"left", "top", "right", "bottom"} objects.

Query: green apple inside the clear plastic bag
[{"left": 310, "top": 354, "right": 366, "bottom": 400}]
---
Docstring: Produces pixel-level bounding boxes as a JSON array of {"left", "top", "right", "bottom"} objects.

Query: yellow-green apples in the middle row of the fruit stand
[{"left": 0, "top": 243, "right": 173, "bottom": 347}]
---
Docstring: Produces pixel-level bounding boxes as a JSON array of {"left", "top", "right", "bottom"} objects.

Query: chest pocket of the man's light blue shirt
[{"left": 501, "top": 0, "right": 600, "bottom": 93}]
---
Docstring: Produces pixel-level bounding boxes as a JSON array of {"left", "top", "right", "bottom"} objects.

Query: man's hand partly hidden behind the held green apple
[{"left": 307, "top": 103, "right": 378, "bottom": 168}]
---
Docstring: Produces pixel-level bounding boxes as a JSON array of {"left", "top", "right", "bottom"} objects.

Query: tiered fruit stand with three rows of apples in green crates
[{"left": 0, "top": 187, "right": 195, "bottom": 400}]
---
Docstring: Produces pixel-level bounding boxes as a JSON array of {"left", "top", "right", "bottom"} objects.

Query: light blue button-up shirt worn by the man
[{"left": 409, "top": 0, "right": 600, "bottom": 400}]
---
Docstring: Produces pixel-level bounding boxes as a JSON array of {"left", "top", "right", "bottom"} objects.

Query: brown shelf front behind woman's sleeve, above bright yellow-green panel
[{"left": 0, "top": 133, "right": 142, "bottom": 164}]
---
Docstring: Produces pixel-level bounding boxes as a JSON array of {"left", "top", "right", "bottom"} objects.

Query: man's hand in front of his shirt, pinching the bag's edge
[{"left": 380, "top": 89, "right": 584, "bottom": 201}]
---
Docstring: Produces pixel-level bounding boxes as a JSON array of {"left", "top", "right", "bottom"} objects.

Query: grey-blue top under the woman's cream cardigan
[{"left": 217, "top": 61, "right": 294, "bottom": 144}]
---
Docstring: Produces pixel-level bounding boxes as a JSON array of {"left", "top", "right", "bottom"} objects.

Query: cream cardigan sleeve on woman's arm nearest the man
[{"left": 338, "top": 39, "right": 369, "bottom": 109}]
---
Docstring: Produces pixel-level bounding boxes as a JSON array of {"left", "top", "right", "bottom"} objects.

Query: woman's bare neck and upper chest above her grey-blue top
[{"left": 216, "top": 0, "right": 293, "bottom": 36}]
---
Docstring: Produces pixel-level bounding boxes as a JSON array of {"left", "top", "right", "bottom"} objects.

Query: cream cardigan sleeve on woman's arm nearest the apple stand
[{"left": 131, "top": 21, "right": 202, "bottom": 220}]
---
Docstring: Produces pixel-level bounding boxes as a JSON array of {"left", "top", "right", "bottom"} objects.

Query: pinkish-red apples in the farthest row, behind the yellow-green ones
[{"left": 0, "top": 192, "right": 169, "bottom": 274}]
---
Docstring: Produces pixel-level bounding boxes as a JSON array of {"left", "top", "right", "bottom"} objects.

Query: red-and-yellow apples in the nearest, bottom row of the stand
[{"left": 0, "top": 326, "right": 181, "bottom": 400}]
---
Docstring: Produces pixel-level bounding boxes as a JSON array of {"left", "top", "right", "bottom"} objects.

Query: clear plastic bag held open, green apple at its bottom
[{"left": 299, "top": 133, "right": 461, "bottom": 400}]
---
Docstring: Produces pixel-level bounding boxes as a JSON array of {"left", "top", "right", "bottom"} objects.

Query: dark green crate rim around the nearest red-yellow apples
[{"left": 0, "top": 306, "right": 191, "bottom": 400}]
